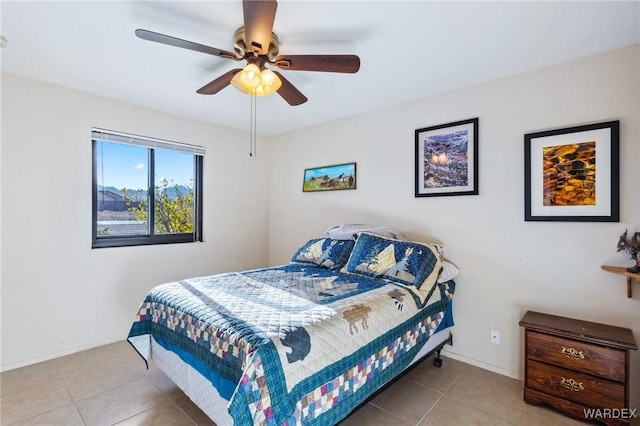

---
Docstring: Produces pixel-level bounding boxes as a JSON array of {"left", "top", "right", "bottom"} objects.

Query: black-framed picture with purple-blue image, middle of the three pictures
[{"left": 415, "top": 118, "right": 478, "bottom": 197}]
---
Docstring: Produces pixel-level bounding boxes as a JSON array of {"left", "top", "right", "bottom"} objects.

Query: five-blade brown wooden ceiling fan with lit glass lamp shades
[{"left": 136, "top": 0, "right": 360, "bottom": 106}]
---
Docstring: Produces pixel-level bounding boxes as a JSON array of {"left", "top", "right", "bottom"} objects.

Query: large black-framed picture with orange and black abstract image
[{"left": 524, "top": 121, "right": 620, "bottom": 222}]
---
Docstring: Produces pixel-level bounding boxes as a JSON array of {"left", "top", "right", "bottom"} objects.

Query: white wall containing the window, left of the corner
[{"left": 1, "top": 74, "right": 268, "bottom": 370}]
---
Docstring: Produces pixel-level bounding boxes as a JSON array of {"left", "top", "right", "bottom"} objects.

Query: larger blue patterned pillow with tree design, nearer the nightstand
[{"left": 344, "top": 232, "right": 442, "bottom": 290}]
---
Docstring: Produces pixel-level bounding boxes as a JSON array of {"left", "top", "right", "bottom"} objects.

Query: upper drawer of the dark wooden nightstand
[{"left": 527, "top": 331, "right": 626, "bottom": 382}]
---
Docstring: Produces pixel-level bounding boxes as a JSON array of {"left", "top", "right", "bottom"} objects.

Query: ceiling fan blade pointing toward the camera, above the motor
[{"left": 242, "top": 0, "right": 278, "bottom": 55}]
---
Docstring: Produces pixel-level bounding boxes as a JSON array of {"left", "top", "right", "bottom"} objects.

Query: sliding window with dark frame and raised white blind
[{"left": 92, "top": 129, "right": 204, "bottom": 248}]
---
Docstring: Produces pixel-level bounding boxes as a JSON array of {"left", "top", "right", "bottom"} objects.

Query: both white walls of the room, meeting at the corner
[{"left": 0, "top": 46, "right": 640, "bottom": 407}]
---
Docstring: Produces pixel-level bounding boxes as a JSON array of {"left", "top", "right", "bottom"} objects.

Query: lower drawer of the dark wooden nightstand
[{"left": 525, "top": 360, "right": 625, "bottom": 408}]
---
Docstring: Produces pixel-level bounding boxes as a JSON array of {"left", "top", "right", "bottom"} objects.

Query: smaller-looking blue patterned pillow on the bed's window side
[{"left": 291, "top": 238, "right": 354, "bottom": 270}]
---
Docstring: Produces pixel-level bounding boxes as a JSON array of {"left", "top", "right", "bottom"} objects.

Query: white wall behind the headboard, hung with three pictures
[{"left": 269, "top": 45, "right": 640, "bottom": 407}]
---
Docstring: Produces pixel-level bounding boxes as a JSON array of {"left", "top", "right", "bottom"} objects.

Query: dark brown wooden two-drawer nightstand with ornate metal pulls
[{"left": 519, "top": 311, "right": 640, "bottom": 425}]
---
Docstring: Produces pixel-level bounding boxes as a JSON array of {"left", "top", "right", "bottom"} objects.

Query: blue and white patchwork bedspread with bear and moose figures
[{"left": 129, "top": 263, "right": 455, "bottom": 425}]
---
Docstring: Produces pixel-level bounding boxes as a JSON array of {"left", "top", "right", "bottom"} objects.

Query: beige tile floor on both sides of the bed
[{"left": 0, "top": 341, "right": 584, "bottom": 426}]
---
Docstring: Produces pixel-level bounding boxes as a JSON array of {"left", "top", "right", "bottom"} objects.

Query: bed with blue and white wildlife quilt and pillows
[{"left": 128, "top": 232, "right": 457, "bottom": 426}]
